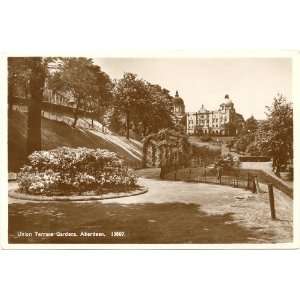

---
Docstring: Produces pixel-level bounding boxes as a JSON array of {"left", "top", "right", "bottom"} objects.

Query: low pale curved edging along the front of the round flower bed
[{"left": 8, "top": 186, "right": 148, "bottom": 201}]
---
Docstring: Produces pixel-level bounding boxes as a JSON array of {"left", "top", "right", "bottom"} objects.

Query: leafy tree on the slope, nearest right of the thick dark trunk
[{"left": 49, "top": 57, "right": 112, "bottom": 127}]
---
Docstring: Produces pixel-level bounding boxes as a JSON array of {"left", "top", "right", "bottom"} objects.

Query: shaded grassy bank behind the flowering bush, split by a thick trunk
[{"left": 8, "top": 111, "right": 139, "bottom": 171}]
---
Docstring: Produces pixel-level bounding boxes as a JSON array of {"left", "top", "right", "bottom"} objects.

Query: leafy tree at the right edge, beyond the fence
[{"left": 256, "top": 94, "right": 293, "bottom": 176}]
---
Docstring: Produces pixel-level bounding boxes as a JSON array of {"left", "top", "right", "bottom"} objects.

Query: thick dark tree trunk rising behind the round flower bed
[{"left": 27, "top": 57, "right": 45, "bottom": 155}]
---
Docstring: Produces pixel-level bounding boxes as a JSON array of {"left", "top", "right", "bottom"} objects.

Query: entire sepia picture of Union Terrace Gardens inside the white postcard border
[{"left": 7, "top": 56, "right": 294, "bottom": 247}]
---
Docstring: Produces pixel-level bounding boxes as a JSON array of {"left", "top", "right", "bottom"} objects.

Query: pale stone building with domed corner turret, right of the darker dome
[{"left": 186, "top": 95, "right": 241, "bottom": 135}]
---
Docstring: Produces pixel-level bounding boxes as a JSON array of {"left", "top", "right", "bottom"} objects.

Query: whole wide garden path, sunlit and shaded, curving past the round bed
[{"left": 9, "top": 169, "right": 292, "bottom": 243}]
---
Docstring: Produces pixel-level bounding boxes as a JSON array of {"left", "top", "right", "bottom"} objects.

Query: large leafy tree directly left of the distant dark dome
[{"left": 112, "top": 73, "right": 173, "bottom": 139}]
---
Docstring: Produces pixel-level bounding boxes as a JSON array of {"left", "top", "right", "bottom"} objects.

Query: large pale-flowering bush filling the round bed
[{"left": 17, "top": 147, "right": 137, "bottom": 195}]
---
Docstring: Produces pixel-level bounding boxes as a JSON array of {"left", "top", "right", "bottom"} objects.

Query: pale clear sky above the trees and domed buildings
[{"left": 94, "top": 58, "right": 292, "bottom": 119}]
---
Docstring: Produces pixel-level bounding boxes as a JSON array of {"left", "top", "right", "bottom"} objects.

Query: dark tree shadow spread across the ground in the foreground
[{"left": 9, "top": 199, "right": 255, "bottom": 243}]
